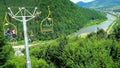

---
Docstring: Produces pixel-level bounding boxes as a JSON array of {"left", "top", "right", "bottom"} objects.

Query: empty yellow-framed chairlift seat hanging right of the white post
[{"left": 40, "top": 6, "right": 54, "bottom": 33}]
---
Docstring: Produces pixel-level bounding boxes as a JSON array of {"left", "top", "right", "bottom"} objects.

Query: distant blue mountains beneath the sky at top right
[{"left": 77, "top": 0, "right": 120, "bottom": 8}]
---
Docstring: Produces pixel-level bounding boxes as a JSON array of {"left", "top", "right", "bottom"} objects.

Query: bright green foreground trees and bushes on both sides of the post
[{"left": 2, "top": 29, "right": 120, "bottom": 68}]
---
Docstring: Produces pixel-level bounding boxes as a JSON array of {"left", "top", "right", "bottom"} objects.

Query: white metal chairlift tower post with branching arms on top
[{"left": 8, "top": 7, "right": 37, "bottom": 68}]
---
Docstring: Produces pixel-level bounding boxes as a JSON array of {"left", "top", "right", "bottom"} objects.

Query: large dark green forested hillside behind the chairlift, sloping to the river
[{"left": 0, "top": 0, "right": 106, "bottom": 39}]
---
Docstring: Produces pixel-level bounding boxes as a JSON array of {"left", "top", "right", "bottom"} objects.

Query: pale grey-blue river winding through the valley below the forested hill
[{"left": 69, "top": 14, "right": 116, "bottom": 36}]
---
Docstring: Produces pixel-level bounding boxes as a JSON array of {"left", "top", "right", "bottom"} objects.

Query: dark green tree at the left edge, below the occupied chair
[{"left": 0, "top": 23, "right": 13, "bottom": 68}]
